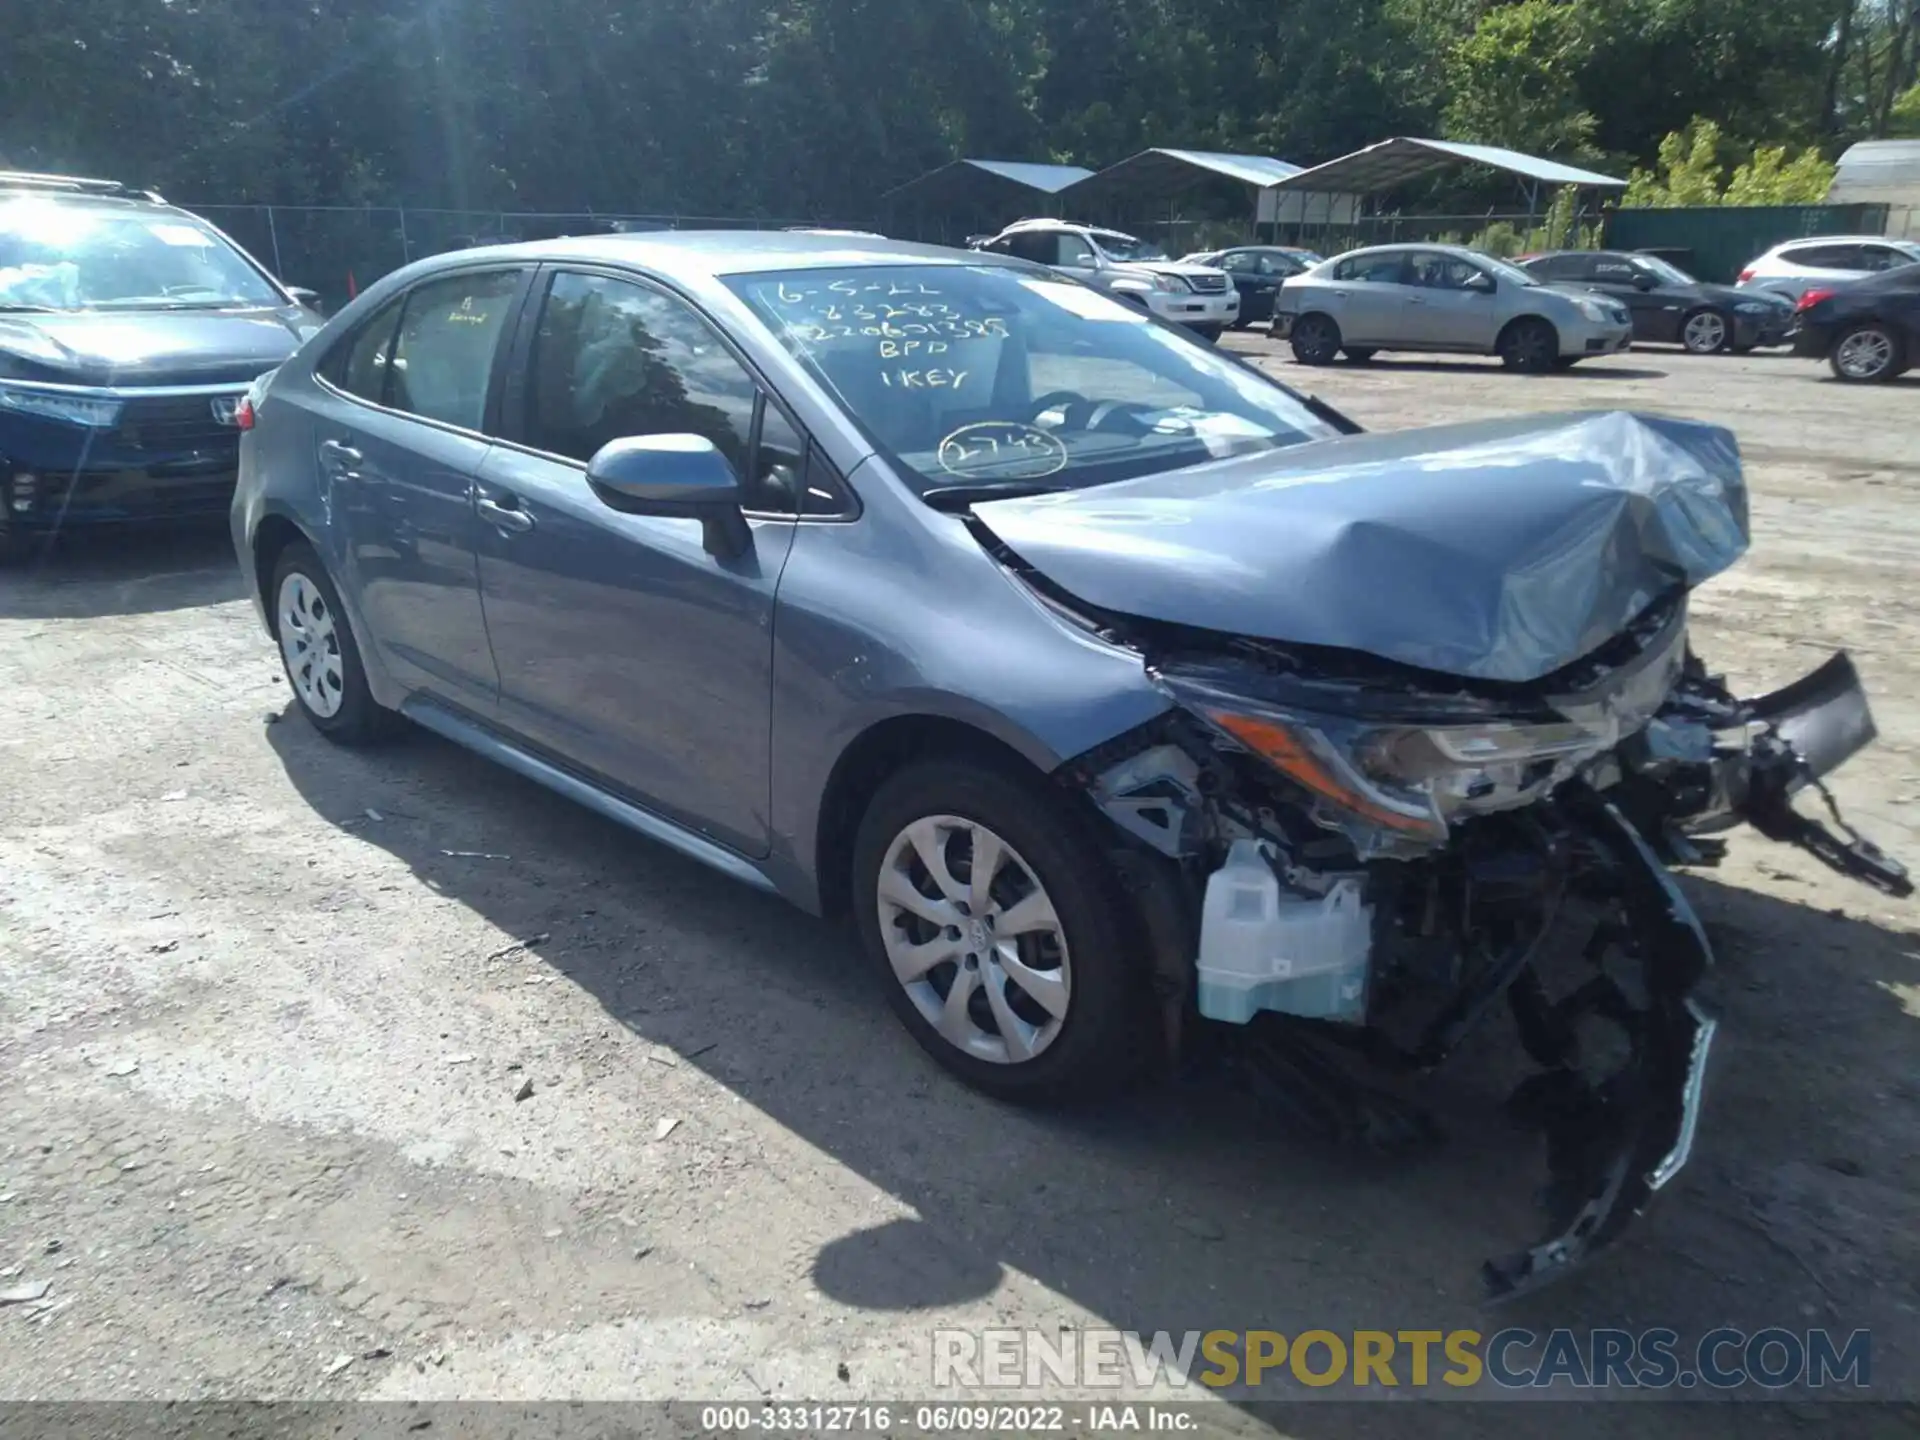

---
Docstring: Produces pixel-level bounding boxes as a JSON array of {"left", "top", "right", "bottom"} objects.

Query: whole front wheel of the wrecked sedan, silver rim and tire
[{"left": 852, "top": 760, "right": 1152, "bottom": 1100}]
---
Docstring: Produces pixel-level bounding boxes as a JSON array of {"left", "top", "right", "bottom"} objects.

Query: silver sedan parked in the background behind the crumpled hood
[{"left": 1269, "top": 246, "right": 1634, "bottom": 371}]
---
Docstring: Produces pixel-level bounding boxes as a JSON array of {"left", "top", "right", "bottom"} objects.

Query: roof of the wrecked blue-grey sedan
[{"left": 440, "top": 230, "right": 1016, "bottom": 276}]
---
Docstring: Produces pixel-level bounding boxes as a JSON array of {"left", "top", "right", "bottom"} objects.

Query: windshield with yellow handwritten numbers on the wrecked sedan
[{"left": 728, "top": 265, "right": 1334, "bottom": 493}]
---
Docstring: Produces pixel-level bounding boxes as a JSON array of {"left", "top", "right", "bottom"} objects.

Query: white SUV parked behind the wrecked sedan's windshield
[{"left": 973, "top": 221, "right": 1240, "bottom": 340}]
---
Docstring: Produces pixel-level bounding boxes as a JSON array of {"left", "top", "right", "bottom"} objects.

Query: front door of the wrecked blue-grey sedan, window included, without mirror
[{"left": 478, "top": 269, "right": 808, "bottom": 856}]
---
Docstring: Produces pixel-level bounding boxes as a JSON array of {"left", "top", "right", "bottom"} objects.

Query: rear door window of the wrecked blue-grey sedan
[{"left": 386, "top": 271, "right": 520, "bottom": 430}]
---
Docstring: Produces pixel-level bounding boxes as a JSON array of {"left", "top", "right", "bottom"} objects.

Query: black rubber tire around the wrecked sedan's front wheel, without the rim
[{"left": 851, "top": 758, "right": 1156, "bottom": 1102}]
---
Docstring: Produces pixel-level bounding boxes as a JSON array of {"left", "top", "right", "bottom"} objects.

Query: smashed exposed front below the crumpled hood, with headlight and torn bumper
[{"left": 1073, "top": 591, "right": 1912, "bottom": 1300}]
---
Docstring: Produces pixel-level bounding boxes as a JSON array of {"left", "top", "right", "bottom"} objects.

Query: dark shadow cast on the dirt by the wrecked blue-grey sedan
[{"left": 265, "top": 712, "right": 1920, "bottom": 1436}]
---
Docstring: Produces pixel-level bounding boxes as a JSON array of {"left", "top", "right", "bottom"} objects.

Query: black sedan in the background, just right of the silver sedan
[{"left": 1519, "top": 250, "right": 1793, "bottom": 355}]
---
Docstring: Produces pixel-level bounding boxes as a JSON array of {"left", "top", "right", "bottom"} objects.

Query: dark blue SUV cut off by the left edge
[{"left": 0, "top": 171, "right": 321, "bottom": 555}]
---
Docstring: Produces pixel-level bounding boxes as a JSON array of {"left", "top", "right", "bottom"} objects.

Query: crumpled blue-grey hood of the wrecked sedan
[{"left": 973, "top": 411, "right": 1749, "bottom": 682}]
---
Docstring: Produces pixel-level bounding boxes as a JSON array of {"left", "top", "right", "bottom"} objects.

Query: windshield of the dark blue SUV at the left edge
[{"left": 0, "top": 198, "right": 286, "bottom": 311}]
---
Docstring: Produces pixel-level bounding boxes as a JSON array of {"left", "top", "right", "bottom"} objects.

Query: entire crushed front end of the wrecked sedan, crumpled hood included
[{"left": 973, "top": 413, "right": 1912, "bottom": 1300}]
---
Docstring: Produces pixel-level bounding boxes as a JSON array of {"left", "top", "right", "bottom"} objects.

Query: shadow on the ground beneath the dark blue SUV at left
[{"left": 0, "top": 520, "right": 246, "bottom": 620}]
